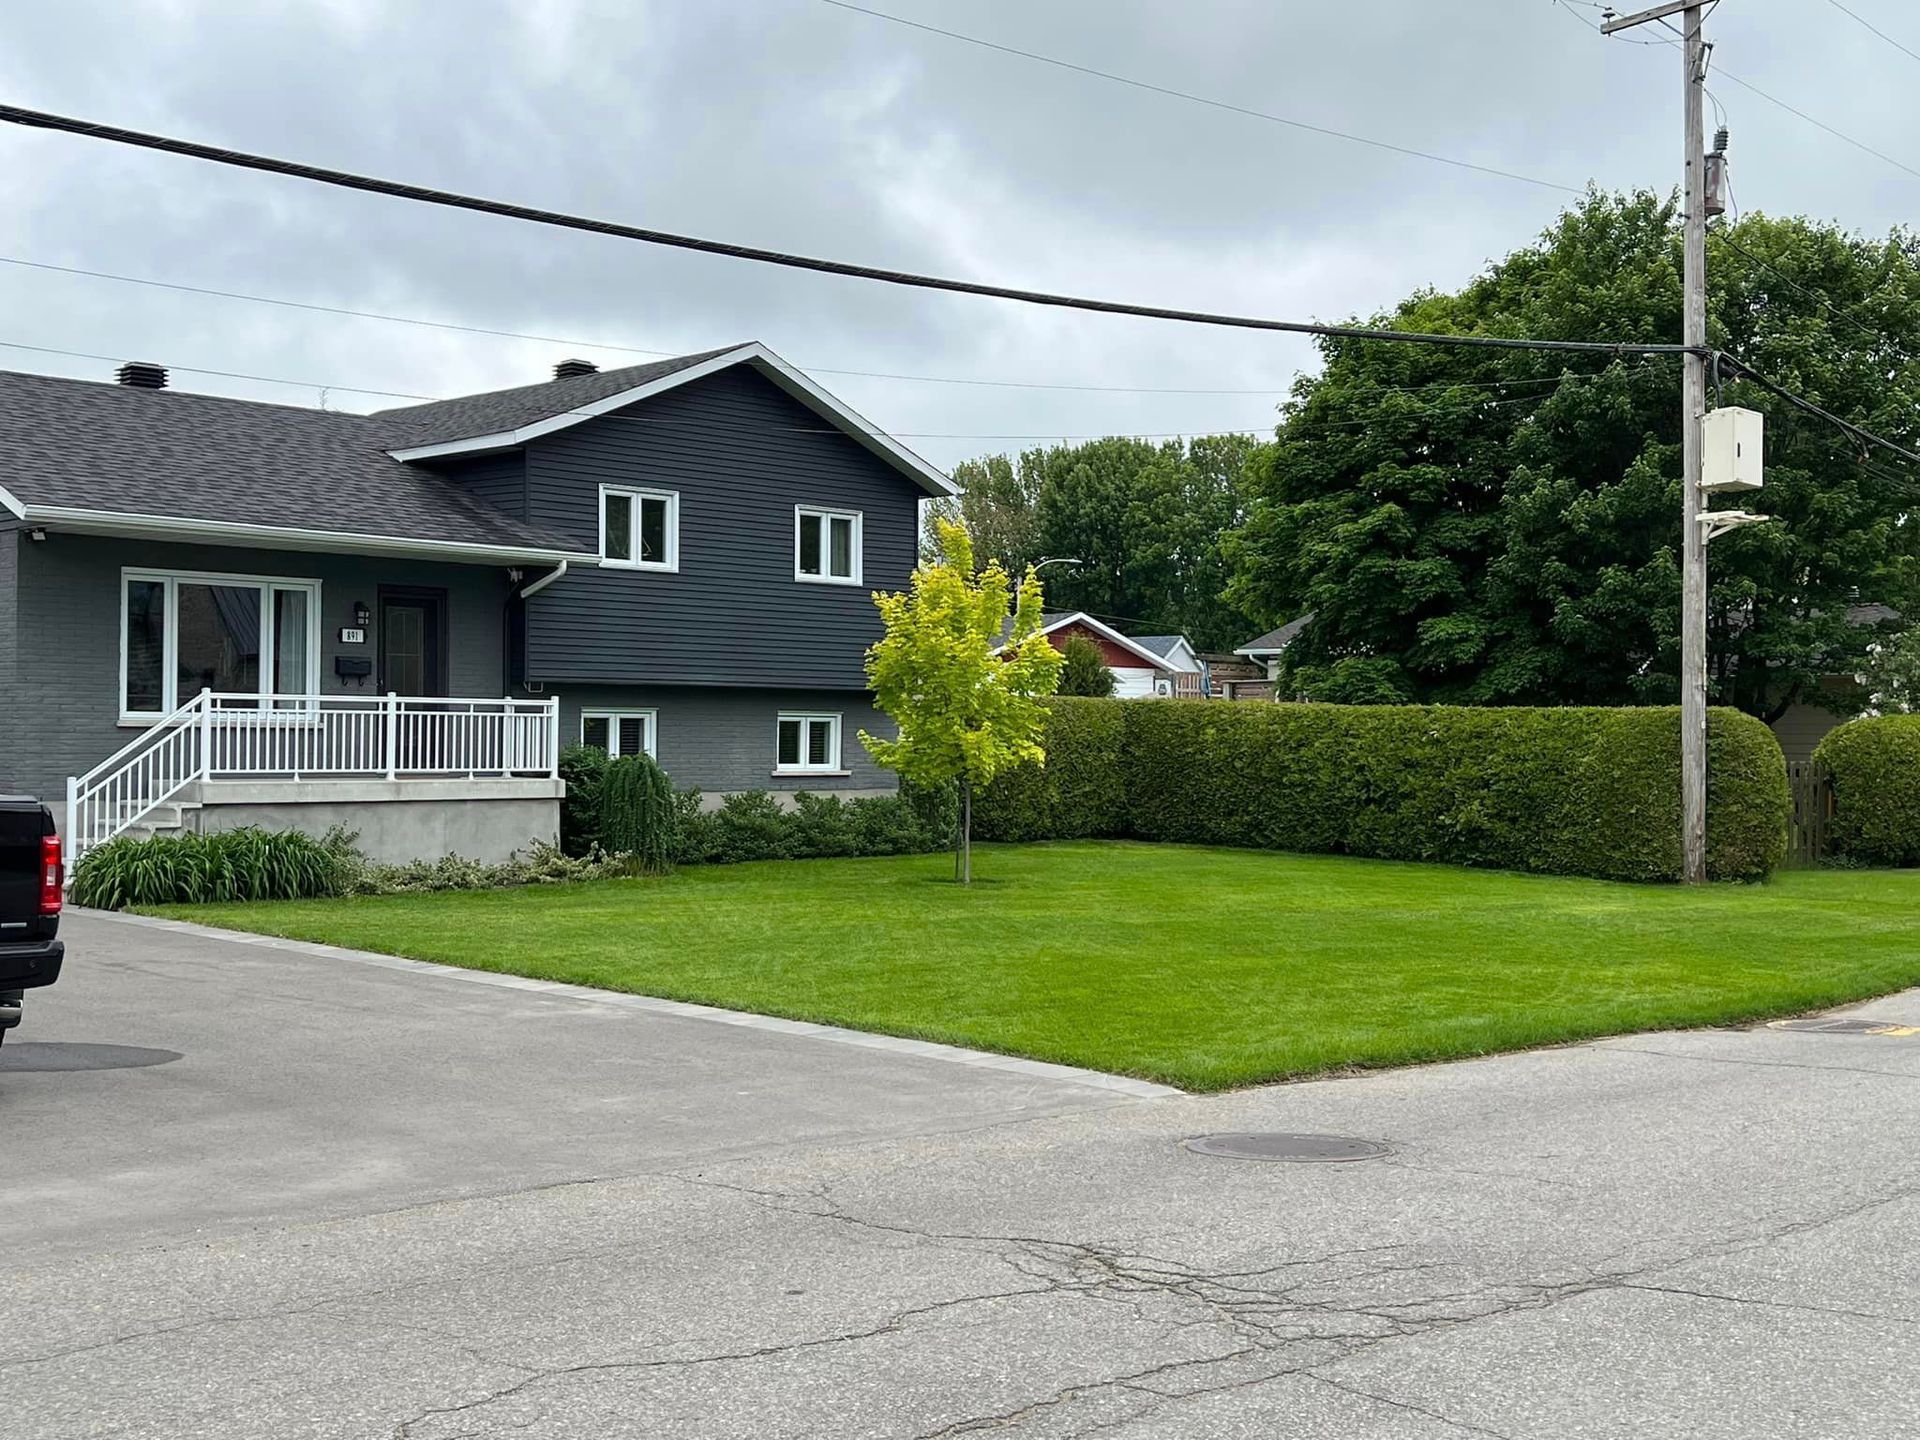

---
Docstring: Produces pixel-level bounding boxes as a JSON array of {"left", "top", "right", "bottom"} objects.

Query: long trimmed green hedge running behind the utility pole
[{"left": 973, "top": 699, "right": 1788, "bottom": 879}]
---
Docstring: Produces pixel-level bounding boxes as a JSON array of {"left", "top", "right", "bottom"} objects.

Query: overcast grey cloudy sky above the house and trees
[{"left": 0, "top": 0, "right": 1920, "bottom": 465}]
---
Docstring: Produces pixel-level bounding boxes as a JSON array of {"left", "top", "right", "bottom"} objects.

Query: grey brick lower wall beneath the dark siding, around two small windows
[{"left": 561, "top": 685, "right": 897, "bottom": 795}]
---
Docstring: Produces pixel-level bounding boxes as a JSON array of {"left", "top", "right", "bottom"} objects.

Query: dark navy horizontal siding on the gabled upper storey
[{"left": 526, "top": 367, "right": 922, "bottom": 689}]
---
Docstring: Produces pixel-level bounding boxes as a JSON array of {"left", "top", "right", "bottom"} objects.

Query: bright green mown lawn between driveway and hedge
[{"left": 145, "top": 843, "right": 1920, "bottom": 1089}]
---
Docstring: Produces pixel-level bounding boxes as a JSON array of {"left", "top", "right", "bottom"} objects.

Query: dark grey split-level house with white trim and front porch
[{"left": 0, "top": 344, "right": 952, "bottom": 858}]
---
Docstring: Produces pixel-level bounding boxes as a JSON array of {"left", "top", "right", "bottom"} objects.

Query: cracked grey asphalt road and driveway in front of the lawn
[{"left": 11, "top": 918, "right": 1920, "bottom": 1440}]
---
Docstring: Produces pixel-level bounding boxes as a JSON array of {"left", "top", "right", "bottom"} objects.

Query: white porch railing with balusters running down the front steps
[{"left": 65, "top": 689, "right": 561, "bottom": 862}]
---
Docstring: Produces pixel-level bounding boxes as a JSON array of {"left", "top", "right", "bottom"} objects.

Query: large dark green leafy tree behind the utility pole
[{"left": 1231, "top": 194, "right": 1920, "bottom": 718}]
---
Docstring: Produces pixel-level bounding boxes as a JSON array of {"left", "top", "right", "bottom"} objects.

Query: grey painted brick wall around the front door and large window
[{"left": 4, "top": 532, "right": 507, "bottom": 797}]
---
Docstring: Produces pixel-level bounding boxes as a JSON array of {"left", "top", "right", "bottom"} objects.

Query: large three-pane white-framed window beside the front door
[{"left": 119, "top": 570, "right": 321, "bottom": 722}]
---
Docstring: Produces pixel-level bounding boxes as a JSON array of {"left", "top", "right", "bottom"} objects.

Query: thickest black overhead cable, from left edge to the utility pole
[{"left": 0, "top": 104, "right": 1686, "bottom": 355}]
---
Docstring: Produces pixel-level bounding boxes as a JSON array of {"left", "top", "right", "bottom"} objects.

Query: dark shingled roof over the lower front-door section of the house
[{"left": 0, "top": 371, "right": 591, "bottom": 555}]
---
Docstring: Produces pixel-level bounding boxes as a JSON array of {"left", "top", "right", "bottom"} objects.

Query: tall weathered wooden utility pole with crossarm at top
[{"left": 1601, "top": 0, "right": 1707, "bottom": 885}]
